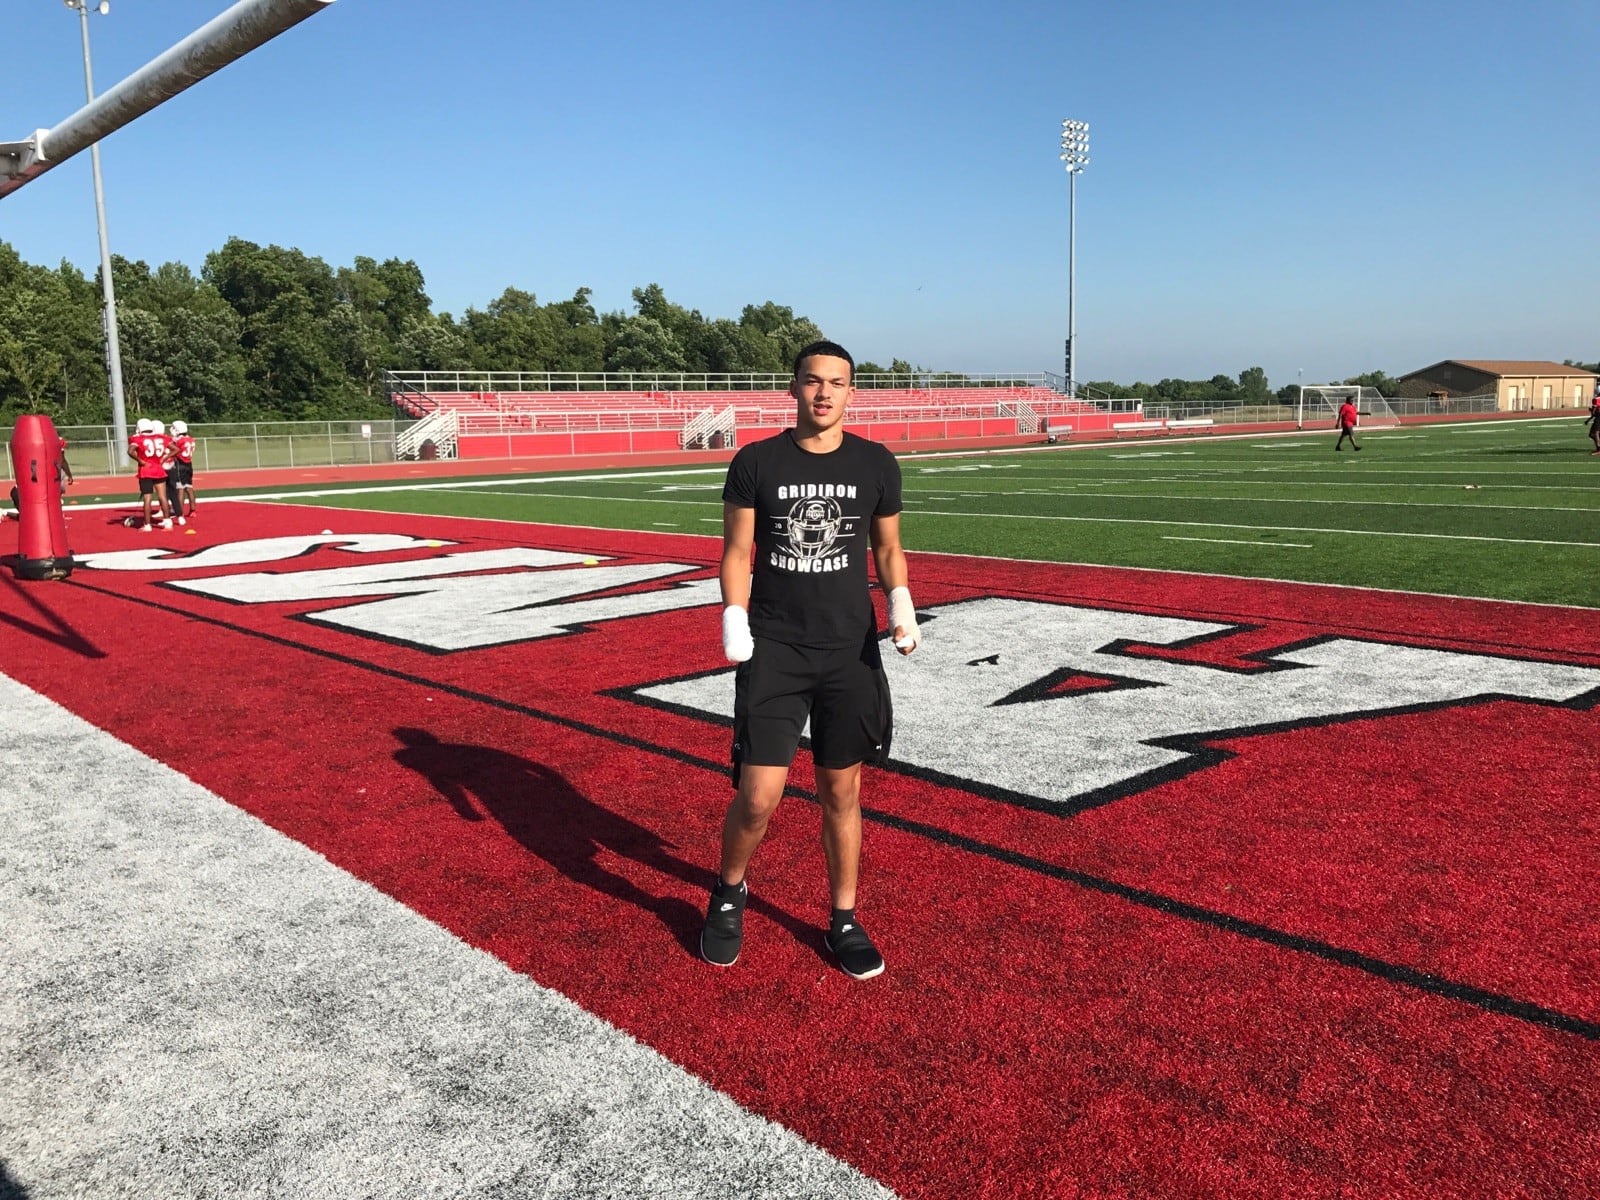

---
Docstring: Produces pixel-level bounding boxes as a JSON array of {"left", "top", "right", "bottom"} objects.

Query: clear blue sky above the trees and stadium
[{"left": 0, "top": 0, "right": 1600, "bottom": 387}]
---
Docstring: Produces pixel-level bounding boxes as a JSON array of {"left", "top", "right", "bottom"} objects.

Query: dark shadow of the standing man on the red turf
[{"left": 384, "top": 726, "right": 816, "bottom": 955}]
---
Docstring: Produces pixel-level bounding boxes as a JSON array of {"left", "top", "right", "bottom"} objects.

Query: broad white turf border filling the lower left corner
[{"left": 0, "top": 674, "right": 891, "bottom": 1200}]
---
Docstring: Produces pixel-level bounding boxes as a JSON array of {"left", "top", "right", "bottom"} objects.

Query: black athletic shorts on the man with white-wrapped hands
[{"left": 733, "top": 634, "right": 894, "bottom": 784}]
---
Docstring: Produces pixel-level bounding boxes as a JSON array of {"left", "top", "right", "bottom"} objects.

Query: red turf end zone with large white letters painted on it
[{"left": 0, "top": 502, "right": 1600, "bottom": 1197}]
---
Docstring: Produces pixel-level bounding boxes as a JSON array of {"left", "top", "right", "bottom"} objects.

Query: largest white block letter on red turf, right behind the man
[{"left": 640, "top": 598, "right": 1600, "bottom": 808}]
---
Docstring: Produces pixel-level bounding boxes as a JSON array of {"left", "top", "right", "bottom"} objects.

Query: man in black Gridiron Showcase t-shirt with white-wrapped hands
[{"left": 701, "top": 342, "right": 920, "bottom": 979}]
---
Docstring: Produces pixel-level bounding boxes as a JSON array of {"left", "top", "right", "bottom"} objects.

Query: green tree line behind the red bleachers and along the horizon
[{"left": 0, "top": 238, "right": 1593, "bottom": 426}]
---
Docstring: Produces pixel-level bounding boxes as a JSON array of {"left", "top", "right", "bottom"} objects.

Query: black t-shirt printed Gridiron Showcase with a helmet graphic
[{"left": 722, "top": 429, "right": 901, "bottom": 646}]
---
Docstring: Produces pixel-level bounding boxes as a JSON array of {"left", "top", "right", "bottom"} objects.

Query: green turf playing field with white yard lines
[{"left": 275, "top": 418, "right": 1600, "bottom": 606}]
